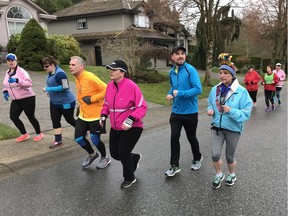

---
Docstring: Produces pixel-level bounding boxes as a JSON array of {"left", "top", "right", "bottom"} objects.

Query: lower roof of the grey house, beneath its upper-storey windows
[{"left": 72, "top": 26, "right": 176, "bottom": 43}]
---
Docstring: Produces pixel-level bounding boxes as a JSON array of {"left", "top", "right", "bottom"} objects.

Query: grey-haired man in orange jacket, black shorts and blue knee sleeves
[{"left": 69, "top": 56, "right": 111, "bottom": 169}]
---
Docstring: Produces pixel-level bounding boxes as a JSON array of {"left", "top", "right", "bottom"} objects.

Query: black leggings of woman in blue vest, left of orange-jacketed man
[{"left": 50, "top": 103, "right": 76, "bottom": 129}]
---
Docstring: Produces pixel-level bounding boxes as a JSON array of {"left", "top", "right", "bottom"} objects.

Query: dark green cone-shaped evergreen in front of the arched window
[{"left": 16, "top": 19, "right": 48, "bottom": 71}]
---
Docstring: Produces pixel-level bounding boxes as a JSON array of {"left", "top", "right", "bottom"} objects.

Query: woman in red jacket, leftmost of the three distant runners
[{"left": 244, "top": 66, "right": 261, "bottom": 107}]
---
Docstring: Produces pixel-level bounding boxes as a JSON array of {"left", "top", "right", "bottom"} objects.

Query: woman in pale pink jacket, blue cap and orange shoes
[{"left": 2, "top": 53, "right": 44, "bottom": 142}]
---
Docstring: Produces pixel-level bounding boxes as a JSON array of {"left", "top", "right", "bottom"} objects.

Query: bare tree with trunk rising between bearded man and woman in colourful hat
[{"left": 171, "top": 0, "right": 239, "bottom": 86}]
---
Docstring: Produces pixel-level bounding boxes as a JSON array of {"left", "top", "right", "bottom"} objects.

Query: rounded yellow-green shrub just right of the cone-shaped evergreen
[{"left": 48, "top": 35, "right": 83, "bottom": 64}]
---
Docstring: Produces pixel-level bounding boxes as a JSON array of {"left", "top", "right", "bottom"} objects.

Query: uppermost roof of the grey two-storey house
[{"left": 54, "top": 0, "right": 149, "bottom": 19}]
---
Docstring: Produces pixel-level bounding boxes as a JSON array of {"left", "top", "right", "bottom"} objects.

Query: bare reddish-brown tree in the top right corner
[{"left": 243, "top": 0, "right": 287, "bottom": 69}]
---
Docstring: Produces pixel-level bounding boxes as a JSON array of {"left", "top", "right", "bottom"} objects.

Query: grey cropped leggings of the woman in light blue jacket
[{"left": 211, "top": 130, "right": 241, "bottom": 164}]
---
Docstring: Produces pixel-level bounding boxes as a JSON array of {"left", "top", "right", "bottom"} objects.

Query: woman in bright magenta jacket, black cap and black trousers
[{"left": 100, "top": 60, "right": 147, "bottom": 188}]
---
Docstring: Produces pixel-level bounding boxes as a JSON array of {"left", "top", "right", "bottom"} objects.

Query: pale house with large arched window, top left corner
[{"left": 0, "top": 0, "right": 56, "bottom": 50}]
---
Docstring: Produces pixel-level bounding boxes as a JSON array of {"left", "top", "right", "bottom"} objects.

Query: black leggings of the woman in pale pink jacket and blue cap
[{"left": 10, "top": 96, "right": 41, "bottom": 134}]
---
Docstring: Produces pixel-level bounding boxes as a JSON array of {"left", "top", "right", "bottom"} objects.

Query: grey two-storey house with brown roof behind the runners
[{"left": 48, "top": 0, "right": 187, "bottom": 67}]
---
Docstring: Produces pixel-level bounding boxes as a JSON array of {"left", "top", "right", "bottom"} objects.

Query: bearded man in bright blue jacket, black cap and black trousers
[{"left": 165, "top": 46, "right": 203, "bottom": 177}]
